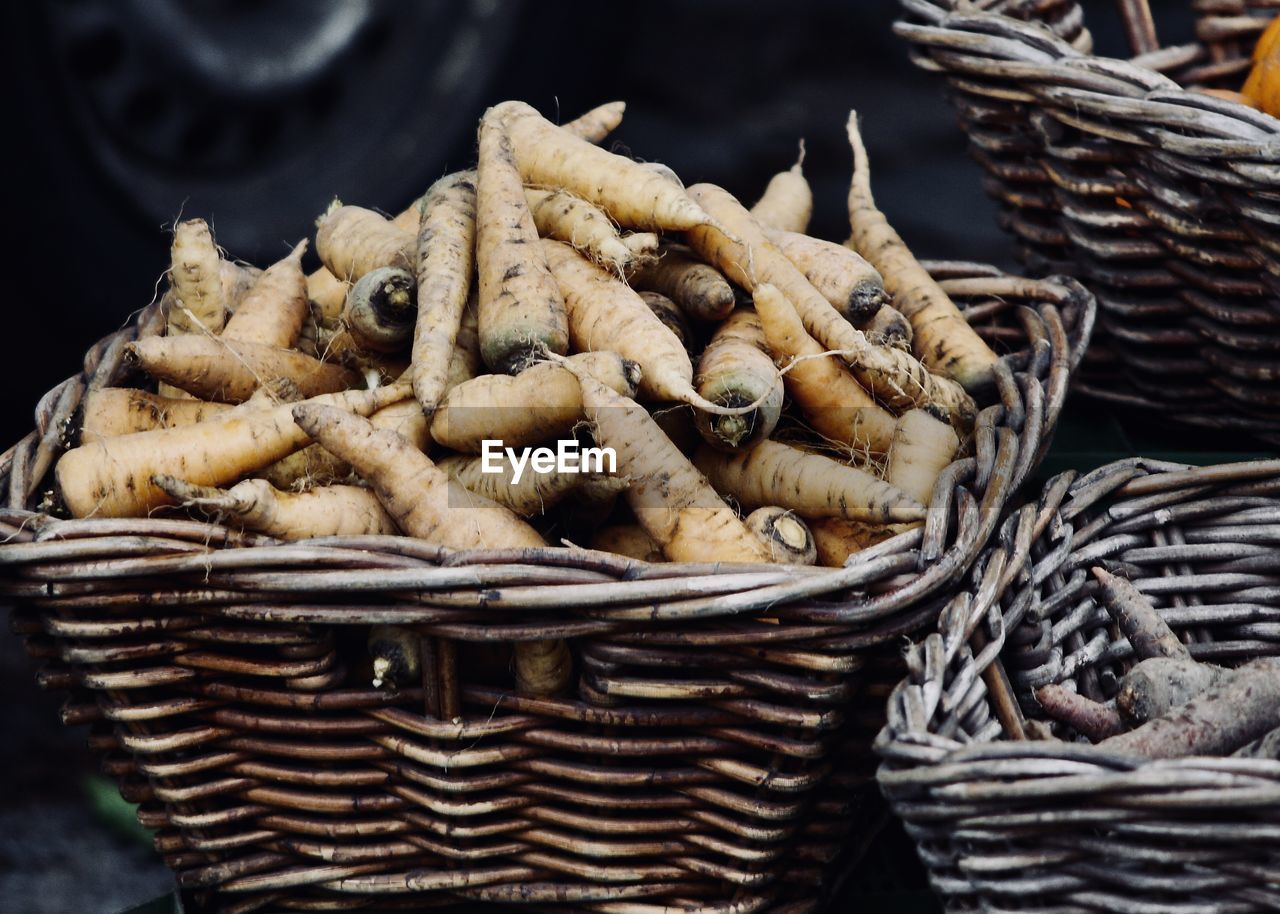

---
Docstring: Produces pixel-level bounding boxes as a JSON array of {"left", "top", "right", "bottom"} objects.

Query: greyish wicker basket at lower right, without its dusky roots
[{"left": 877, "top": 460, "right": 1280, "bottom": 914}]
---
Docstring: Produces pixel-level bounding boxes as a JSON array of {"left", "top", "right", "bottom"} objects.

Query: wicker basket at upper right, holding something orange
[{"left": 896, "top": 0, "right": 1280, "bottom": 443}]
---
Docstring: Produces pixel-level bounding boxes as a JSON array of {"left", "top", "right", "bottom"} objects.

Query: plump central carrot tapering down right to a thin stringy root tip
[{"left": 541, "top": 238, "right": 732, "bottom": 413}]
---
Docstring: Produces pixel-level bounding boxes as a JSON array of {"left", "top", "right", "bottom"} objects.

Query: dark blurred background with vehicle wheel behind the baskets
[{"left": 0, "top": 0, "right": 1189, "bottom": 914}]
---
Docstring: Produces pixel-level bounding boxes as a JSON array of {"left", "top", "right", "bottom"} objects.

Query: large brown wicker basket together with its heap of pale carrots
[{"left": 0, "top": 102, "right": 1093, "bottom": 911}]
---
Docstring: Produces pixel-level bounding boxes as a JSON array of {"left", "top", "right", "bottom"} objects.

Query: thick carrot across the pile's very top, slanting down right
[{"left": 494, "top": 101, "right": 727, "bottom": 232}]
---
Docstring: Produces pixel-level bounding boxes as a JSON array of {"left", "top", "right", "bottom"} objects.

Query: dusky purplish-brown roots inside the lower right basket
[{"left": 1032, "top": 568, "right": 1280, "bottom": 759}]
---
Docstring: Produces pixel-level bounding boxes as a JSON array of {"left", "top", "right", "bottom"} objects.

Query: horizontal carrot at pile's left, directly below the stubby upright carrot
[{"left": 127, "top": 334, "right": 357, "bottom": 403}]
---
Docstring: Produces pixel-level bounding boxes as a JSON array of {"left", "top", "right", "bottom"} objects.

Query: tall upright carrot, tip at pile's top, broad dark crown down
[{"left": 476, "top": 109, "right": 568, "bottom": 374}]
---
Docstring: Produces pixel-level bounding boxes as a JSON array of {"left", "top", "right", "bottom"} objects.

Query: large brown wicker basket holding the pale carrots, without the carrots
[{"left": 0, "top": 264, "right": 1094, "bottom": 914}]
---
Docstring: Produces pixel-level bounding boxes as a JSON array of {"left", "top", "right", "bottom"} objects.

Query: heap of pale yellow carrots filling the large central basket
[{"left": 55, "top": 101, "right": 997, "bottom": 640}]
